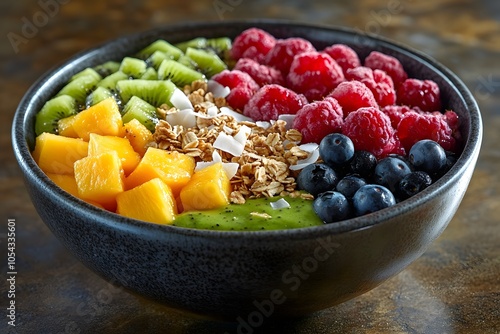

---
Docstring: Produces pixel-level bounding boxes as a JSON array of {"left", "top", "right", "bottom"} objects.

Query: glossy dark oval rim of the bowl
[{"left": 11, "top": 19, "right": 483, "bottom": 241}]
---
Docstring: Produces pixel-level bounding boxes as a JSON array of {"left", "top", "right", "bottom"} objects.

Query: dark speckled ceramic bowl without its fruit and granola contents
[{"left": 12, "top": 21, "right": 482, "bottom": 319}]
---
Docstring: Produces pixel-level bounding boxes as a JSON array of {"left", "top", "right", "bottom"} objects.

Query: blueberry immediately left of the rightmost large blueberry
[{"left": 373, "top": 156, "right": 412, "bottom": 193}]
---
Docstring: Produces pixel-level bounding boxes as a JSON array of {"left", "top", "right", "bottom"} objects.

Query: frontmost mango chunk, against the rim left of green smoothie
[{"left": 116, "top": 178, "right": 177, "bottom": 224}]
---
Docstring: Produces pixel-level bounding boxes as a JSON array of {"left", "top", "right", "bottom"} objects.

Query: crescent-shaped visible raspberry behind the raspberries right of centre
[{"left": 345, "top": 66, "right": 396, "bottom": 107}]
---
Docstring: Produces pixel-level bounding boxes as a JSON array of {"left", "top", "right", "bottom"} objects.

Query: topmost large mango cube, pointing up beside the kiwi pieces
[{"left": 72, "top": 97, "right": 124, "bottom": 141}]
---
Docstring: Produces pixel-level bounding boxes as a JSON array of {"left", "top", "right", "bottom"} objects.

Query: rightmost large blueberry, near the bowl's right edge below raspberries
[{"left": 408, "top": 139, "right": 446, "bottom": 175}]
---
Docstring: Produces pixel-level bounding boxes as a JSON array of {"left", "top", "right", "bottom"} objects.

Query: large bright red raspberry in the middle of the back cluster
[{"left": 286, "top": 51, "right": 344, "bottom": 101}]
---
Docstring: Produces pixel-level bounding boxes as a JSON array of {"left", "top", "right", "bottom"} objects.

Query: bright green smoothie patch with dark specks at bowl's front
[{"left": 173, "top": 197, "right": 324, "bottom": 231}]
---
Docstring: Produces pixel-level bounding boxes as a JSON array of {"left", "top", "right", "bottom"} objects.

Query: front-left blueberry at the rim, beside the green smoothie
[{"left": 313, "top": 191, "right": 352, "bottom": 223}]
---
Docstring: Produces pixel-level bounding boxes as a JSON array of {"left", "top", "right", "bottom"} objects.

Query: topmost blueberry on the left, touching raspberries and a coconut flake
[{"left": 319, "top": 133, "right": 354, "bottom": 168}]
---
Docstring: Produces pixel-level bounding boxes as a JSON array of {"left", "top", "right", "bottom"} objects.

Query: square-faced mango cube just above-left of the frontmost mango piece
[{"left": 75, "top": 151, "right": 124, "bottom": 211}]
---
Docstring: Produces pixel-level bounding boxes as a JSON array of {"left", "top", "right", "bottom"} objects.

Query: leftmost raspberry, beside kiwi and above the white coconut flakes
[{"left": 212, "top": 70, "right": 259, "bottom": 110}]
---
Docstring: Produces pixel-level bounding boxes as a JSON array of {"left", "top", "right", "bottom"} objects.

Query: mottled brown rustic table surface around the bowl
[{"left": 0, "top": 0, "right": 500, "bottom": 333}]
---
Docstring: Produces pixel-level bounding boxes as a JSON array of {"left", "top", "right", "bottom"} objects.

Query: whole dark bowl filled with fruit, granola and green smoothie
[{"left": 12, "top": 21, "right": 482, "bottom": 319}]
